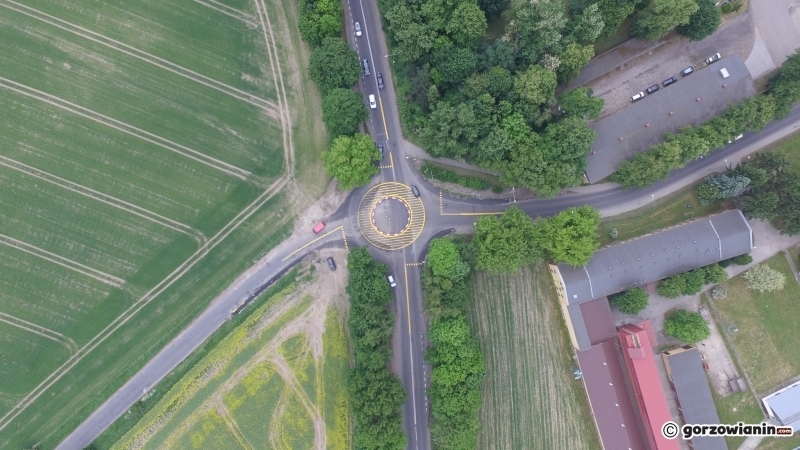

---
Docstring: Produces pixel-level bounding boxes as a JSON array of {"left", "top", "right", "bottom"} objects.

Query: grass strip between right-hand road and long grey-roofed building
[{"left": 597, "top": 186, "right": 733, "bottom": 246}]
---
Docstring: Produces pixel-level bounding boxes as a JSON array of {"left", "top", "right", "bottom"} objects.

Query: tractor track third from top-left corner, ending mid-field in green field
[{"left": 0, "top": 155, "right": 208, "bottom": 247}]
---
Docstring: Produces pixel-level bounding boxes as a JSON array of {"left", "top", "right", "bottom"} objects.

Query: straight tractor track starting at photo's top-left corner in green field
[{"left": 0, "top": 0, "right": 277, "bottom": 117}]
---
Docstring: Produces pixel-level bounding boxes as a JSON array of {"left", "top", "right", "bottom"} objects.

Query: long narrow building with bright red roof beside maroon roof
[{"left": 617, "top": 320, "right": 680, "bottom": 450}]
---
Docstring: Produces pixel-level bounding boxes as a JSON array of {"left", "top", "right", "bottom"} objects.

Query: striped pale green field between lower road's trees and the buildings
[{"left": 468, "top": 264, "right": 600, "bottom": 450}]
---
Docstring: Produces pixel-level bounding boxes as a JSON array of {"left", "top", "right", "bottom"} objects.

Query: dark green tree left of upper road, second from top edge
[{"left": 308, "top": 37, "right": 361, "bottom": 94}]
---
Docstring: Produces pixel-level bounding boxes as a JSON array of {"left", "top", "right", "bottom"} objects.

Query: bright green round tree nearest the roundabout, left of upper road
[{"left": 322, "top": 134, "right": 381, "bottom": 190}]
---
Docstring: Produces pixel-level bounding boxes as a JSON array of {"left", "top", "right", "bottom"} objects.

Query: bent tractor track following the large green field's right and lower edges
[{"left": 0, "top": 0, "right": 306, "bottom": 440}]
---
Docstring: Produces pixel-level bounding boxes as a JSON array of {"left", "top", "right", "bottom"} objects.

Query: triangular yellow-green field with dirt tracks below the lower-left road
[{"left": 113, "top": 260, "right": 350, "bottom": 450}]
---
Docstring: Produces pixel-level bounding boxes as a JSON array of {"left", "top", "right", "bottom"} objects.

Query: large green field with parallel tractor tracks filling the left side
[{"left": 0, "top": 0, "right": 327, "bottom": 448}]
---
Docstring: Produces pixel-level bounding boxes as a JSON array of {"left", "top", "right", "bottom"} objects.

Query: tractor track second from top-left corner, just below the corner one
[{"left": 0, "top": 77, "right": 251, "bottom": 180}]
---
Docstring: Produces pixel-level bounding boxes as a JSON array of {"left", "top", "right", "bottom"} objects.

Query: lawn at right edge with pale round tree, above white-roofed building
[{"left": 714, "top": 253, "right": 800, "bottom": 393}]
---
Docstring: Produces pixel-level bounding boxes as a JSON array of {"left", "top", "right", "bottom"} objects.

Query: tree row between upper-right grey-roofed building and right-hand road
[{"left": 611, "top": 50, "right": 800, "bottom": 189}]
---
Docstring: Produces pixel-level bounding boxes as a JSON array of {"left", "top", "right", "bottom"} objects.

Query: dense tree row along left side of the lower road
[{"left": 347, "top": 247, "right": 408, "bottom": 450}]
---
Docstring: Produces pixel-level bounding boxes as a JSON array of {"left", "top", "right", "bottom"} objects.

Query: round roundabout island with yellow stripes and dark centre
[{"left": 358, "top": 182, "right": 425, "bottom": 250}]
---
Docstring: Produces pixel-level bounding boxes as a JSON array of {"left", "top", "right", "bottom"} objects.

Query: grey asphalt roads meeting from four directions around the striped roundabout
[{"left": 57, "top": 7, "right": 800, "bottom": 450}]
